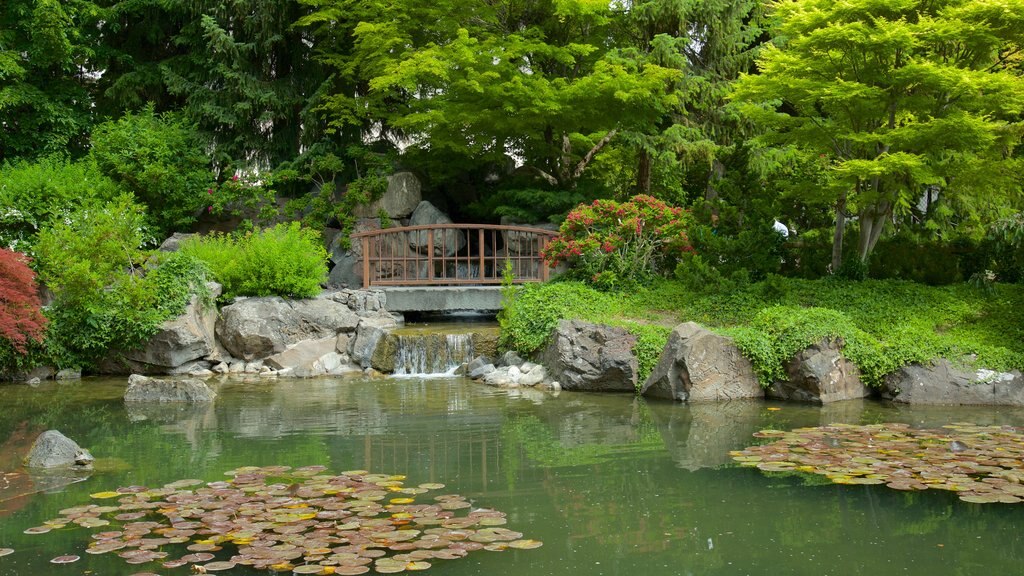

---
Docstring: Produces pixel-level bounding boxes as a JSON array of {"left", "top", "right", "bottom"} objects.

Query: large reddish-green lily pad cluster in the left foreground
[{"left": 19, "top": 466, "right": 541, "bottom": 575}]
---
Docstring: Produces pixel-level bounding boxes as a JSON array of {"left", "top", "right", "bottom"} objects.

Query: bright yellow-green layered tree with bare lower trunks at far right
[{"left": 734, "top": 0, "right": 1024, "bottom": 271}]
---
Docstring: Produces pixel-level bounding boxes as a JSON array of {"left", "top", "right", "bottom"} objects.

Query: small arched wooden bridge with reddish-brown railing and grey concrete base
[{"left": 352, "top": 223, "right": 557, "bottom": 313}]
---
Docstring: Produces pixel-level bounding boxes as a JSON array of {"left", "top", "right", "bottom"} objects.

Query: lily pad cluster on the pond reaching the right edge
[{"left": 729, "top": 423, "right": 1024, "bottom": 504}]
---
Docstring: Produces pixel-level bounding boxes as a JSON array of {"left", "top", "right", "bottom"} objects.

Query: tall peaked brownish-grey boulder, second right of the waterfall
[{"left": 641, "top": 322, "right": 764, "bottom": 402}]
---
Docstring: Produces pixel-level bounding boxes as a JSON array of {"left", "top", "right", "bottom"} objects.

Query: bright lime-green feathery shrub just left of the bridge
[{"left": 181, "top": 222, "right": 327, "bottom": 300}]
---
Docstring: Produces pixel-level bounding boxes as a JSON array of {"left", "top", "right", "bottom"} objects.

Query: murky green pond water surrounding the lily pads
[{"left": 0, "top": 377, "right": 1024, "bottom": 576}]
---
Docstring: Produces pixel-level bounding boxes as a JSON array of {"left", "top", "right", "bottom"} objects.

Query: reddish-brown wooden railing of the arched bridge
[{"left": 352, "top": 223, "right": 557, "bottom": 288}]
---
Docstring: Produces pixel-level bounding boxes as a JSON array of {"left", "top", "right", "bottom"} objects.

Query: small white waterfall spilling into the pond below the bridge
[{"left": 394, "top": 332, "right": 473, "bottom": 376}]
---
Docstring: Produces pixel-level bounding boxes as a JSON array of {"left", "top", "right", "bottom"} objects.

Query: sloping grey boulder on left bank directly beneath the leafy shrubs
[{"left": 124, "top": 282, "right": 221, "bottom": 372}]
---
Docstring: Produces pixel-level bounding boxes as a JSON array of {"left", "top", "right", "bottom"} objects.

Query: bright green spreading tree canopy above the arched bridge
[{"left": 300, "top": 0, "right": 679, "bottom": 189}]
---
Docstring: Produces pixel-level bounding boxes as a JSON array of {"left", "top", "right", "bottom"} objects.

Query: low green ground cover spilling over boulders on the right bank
[{"left": 499, "top": 277, "right": 1024, "bottom": 385}]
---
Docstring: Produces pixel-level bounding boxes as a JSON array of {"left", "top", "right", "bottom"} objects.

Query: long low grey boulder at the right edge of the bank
[{"left": 882, "top": 359, "right": 1024, "bottom": 406}]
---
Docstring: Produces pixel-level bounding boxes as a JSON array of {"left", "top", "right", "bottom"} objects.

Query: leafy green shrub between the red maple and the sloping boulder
[{"left": 30, "top": 197, "right": 207, "bottom": 368}]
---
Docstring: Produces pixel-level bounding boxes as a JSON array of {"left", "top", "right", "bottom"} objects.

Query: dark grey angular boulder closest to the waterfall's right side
[{"left": 538, "top": 320, "right": 639, "bottom": 393}]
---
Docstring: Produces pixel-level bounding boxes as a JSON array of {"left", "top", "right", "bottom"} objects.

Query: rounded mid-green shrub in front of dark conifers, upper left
[{"left": 91, "top": 107, "right": 213, "bottom": 235}]
